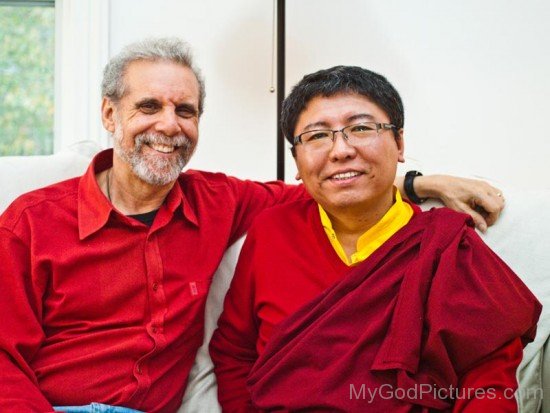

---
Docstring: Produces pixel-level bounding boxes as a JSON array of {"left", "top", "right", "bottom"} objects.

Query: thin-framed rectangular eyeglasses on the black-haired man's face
[{"left": 294, "top": 122, "right": 396, "bottom": 151}]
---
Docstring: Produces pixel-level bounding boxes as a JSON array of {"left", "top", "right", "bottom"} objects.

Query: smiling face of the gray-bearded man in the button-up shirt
[{"left": 102, "top": 61, "right": 199, "bottom": 185}]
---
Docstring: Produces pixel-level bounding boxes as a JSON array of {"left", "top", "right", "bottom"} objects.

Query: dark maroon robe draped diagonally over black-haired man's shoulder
[{"left": 248, "top": 209, "right": 541, "bottom": 412}]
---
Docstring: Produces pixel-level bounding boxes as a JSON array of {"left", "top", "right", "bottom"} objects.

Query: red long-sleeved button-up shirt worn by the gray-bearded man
[{"left": 0, "top": 151, "right": 304, "bottom": 412}]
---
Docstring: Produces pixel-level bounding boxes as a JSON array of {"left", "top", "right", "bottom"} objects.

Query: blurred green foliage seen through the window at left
[{"left": 0, "top": 6, "right": 55, "bottom": 156}]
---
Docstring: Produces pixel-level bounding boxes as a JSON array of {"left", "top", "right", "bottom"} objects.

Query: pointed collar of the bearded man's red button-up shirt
[{"left": 78, "top": 149, "right": 199, "bottom": 240}]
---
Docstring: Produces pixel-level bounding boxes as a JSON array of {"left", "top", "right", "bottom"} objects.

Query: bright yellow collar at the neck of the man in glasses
[{"left": 318, "top": 187, "right": 413, "bottom": 265}]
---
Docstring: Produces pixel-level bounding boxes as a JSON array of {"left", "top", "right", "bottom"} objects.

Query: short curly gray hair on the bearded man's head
[{"left": 101, "top": 37, "right": 206, "bottom": 115}]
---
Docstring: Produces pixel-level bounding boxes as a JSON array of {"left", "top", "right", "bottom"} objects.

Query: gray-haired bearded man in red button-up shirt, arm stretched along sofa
[{"left": 0, "top": 39, "right": 502, "bottom": 412}]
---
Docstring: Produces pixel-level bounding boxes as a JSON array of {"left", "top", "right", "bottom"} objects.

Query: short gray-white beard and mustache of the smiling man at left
[{"left": 113, "top": 122, "right": 194, "bottom": 186}]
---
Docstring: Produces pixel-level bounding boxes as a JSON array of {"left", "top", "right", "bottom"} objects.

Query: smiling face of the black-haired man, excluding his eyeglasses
[{"left": 294, "top": 93, "right": 404, "bottom": 216}]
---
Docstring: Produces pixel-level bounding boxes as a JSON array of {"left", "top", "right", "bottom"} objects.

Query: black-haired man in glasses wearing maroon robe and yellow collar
[{"left": 210, "top": 66, "right": 541, "bottom": 413}]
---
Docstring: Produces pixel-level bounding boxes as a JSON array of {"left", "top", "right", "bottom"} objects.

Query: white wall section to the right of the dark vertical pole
[{"left": 287, "top": 0, "right": 550, "bottom": 189}]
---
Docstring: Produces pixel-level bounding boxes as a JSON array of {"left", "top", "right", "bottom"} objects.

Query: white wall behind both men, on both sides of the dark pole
[{"left": 110, "top": 0, "right": 550, "bottom": 189}]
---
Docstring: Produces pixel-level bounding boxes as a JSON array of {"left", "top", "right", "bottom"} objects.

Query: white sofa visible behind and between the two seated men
[{"left": 0, "top": 142, "right": 550, "bottom": 413}]
